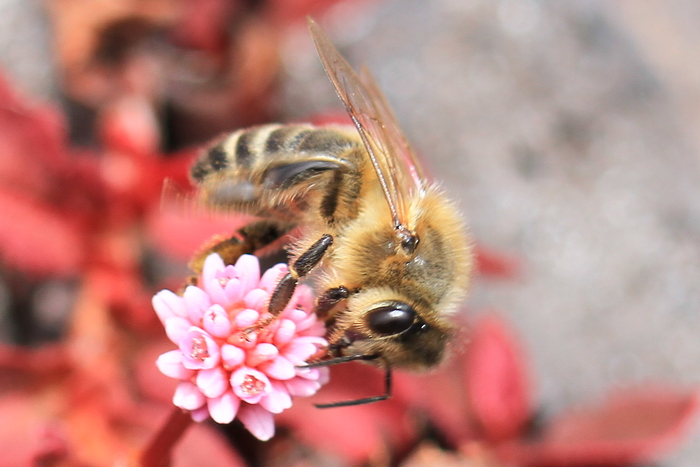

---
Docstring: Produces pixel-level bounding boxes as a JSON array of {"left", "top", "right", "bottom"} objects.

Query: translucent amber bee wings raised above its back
[{"left": 309, "top": 18, "right": 425, "bottom": 227}]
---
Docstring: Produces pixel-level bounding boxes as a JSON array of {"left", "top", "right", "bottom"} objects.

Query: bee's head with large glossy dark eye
[{"left": 331, "top": 292, "right": 453, "bottom": 370}]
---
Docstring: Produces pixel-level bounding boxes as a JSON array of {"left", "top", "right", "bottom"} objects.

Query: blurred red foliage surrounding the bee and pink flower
[{"left": 0, "top": 0, "right": 699, "bottom": 467}]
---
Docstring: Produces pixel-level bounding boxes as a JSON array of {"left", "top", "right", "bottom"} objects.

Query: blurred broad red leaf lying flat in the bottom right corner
[{"left": 501, "top": 388, "right": 700, "bottom": 467}]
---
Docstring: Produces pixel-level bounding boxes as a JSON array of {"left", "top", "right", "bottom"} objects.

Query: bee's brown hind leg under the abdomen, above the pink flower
[{"left": 189, "top": 221, "right": 292, "bottom": 274}]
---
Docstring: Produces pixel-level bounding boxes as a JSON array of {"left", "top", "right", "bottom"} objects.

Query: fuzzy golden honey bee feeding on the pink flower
[{"left": 191, "top": 19, "right": 472, "bottom": 407}]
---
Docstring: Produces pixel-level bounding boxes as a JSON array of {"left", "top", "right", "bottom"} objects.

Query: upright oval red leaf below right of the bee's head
[{"left": 466, "top": 316, "right": 532, "bottom": 441}]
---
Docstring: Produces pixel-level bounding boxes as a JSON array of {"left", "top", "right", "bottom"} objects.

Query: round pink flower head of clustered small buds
[{"left": 153, "top": 254, "right": 328, "bottom": 441}]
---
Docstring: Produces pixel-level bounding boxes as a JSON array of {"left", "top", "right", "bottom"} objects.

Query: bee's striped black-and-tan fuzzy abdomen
[{"left": 191, "top": 125, "right": 365, "bottom": 227}]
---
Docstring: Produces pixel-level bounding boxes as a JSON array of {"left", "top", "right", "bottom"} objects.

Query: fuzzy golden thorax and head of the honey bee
[{"left": 320, "top": 186, "right": 472, "bottom": 369}]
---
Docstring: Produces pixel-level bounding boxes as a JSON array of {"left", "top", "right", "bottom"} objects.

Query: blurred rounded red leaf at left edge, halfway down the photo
[{"left": 0, "top": 190, "right": 86, "bottom": 276}]
